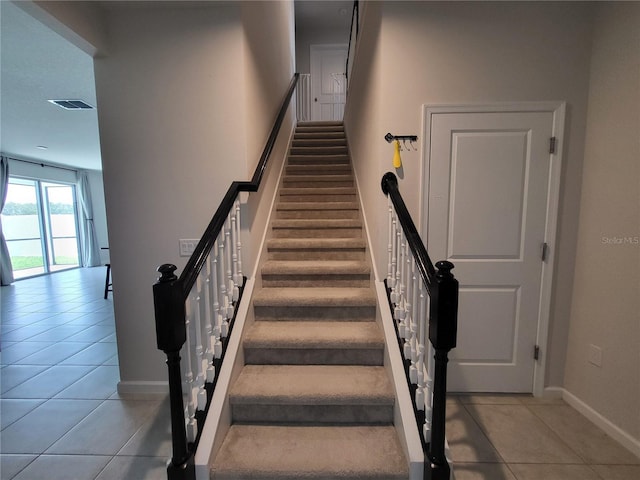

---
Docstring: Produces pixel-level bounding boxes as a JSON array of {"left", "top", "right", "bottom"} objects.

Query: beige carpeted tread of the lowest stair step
[{"left": 211, "top": 425, "right": 409, "bottom": 480}]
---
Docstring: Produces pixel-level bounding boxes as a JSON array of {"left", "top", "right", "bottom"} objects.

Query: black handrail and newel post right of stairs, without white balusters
[{"left": 382, "top": 172, "right": 458, "bottom": 480}]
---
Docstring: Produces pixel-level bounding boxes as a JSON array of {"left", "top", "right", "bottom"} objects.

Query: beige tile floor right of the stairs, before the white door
[{"left": 447, "top": 395, "right": 640, "bottom": 480}]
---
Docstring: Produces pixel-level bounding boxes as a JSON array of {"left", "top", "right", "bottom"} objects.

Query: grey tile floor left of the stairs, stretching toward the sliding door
[{"left": 0, "top": 267, "right": 171, "bottom": 480}]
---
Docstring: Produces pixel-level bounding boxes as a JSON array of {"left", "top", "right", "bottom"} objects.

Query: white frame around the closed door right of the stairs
[{"left": 419, "top": 102, "right": 566, "bottom": 397}]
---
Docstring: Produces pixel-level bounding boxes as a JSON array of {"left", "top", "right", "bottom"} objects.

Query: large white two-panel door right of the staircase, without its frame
[{"left": 427, "top": 111, "right": 553, "bottom": 392}]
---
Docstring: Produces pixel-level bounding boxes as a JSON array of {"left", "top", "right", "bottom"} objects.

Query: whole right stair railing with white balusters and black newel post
[{"left": 382, "top": 173, "right": 458, "bottom": 480}]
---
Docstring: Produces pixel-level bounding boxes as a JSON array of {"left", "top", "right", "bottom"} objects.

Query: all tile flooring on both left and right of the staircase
[{"left": 0, "top": 267, "right": 640, "bottom": 480}]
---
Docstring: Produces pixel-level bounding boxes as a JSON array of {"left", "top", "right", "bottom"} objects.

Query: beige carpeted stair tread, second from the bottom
[{"left": 229, "top": 365, "right": 395, "bottom": 406}]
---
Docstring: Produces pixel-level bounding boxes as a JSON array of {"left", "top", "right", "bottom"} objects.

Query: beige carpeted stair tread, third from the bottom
[{"left": 243, "top": 322, "right": 384, "bottom": 350}]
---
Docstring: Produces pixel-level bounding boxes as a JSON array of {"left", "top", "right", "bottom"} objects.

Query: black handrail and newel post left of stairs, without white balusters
[{"left": 153, "top": 73, "right": 300, "bottom": 480}]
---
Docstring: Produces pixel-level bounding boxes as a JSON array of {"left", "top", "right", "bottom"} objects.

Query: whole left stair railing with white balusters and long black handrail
[{"left": 153, "top": 73, "right": 298, "bottom": 480}]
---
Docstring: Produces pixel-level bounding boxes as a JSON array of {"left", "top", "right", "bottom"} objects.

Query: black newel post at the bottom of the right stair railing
[{"left": 425, "top": 261, "right": 458, "bottom": 480}]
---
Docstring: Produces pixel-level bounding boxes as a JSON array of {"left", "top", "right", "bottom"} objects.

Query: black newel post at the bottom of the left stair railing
[{"left": 153, "top": 264, "right": 195, "bottom": 480}]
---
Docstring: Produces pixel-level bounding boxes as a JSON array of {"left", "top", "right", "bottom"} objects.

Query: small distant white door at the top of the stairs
[{"left": 310, "top": 45, "right": 347, "bottom": 121}]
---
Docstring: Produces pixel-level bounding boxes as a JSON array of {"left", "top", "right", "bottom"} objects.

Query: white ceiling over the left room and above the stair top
[{"left": 0, "top": 0, "right": 353, "bottom": 170}]
